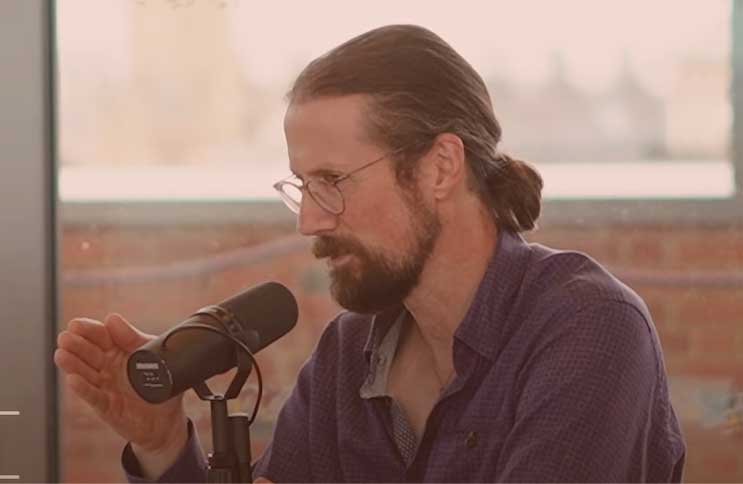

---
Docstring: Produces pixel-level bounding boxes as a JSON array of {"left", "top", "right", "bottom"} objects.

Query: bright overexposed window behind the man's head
[{"left": 58, "top": 0, "right": 736, "bottom": 206}]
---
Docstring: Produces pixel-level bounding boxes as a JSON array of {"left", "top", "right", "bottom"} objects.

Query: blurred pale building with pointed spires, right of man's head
[{"left": 489, "top": 54, "right": 667, "bottom": 163}]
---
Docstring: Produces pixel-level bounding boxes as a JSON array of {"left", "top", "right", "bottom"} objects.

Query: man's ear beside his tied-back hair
[{"left": 425, "top": 133, "right": 467, "bottom": 200}]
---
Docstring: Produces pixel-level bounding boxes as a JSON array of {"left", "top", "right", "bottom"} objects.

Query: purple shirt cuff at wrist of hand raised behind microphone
[{"left": 121, "top": 419, "right": 207, "bottom": 483}]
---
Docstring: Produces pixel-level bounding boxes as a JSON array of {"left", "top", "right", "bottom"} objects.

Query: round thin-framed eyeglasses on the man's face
[{"left": 273, "top": 148, "right": 404, "bottom": 215}]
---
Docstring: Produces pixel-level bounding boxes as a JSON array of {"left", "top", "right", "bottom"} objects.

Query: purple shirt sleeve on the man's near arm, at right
[{"left": 497, "top": 301, "right": 671, "bottom": 482}]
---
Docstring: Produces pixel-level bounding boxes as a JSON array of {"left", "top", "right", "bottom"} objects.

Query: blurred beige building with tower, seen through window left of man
[{"left": 60, "top": 0, "right": 266, "bottom": 165}]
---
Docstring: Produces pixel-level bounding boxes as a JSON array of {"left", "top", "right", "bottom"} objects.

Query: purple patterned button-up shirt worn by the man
[{"left": 124, "top": 231, "right": 685, "bottom": 482}]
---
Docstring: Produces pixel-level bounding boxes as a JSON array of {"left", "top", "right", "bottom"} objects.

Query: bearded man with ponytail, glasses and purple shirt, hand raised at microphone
[{"left": 55, "top": 26, "right": 685, "bottom": 482}]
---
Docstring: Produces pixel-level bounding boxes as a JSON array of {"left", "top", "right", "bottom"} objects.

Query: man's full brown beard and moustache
[{"left": 312, "top": 192, "right": 441, "bottom": 314}]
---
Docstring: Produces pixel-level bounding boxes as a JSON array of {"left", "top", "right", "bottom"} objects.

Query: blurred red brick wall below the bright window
[{"left": 60, "top": 224, "right": 743, "bottom": 482}]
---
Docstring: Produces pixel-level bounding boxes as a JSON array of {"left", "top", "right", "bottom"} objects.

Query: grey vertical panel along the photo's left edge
[{"left": 0, "top": 0, "right": 58, "bottom": 482}]
